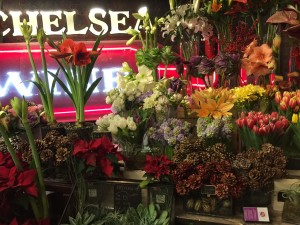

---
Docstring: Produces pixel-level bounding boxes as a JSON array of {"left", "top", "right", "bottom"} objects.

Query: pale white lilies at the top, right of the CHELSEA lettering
[{"left": 162, "top": 4, "right": 213, "bottom": 41}]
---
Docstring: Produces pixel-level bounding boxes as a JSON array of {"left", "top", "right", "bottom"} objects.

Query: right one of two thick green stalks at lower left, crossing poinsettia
[{"left": 22, "top": 120, "right": 49, "bottom": 218}]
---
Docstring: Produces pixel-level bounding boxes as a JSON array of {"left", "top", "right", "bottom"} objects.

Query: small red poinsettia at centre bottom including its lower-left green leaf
[{"left": 140, "top": 155, "right": 172, "bottom": 188}]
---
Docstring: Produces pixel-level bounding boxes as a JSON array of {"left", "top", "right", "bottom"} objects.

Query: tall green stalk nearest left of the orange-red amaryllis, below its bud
[{"left": 40, "top": 45, "right": 56, "bottom": 124}]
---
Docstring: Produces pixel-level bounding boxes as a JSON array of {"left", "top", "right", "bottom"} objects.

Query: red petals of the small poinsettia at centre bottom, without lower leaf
[{"left": 144, "top": 155, "right": 172, "bottom": 179}]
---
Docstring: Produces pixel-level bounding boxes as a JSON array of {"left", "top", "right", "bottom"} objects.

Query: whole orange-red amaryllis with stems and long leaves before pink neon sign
[{"left": 48, "top": 34, "right": 101, "bottom": 126}]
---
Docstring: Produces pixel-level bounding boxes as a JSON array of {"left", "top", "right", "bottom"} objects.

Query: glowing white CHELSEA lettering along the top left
[{"left": 0, "top": 8, "right": 144, "bottom": 36}]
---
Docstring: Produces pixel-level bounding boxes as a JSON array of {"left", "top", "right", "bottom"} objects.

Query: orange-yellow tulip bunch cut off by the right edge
[{"left": 275, "top": 90, "right": 300, "bottom": 120}]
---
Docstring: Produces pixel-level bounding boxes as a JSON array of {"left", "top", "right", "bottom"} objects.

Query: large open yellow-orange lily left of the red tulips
[{"left": 191, "top": 88, "right": 235, "bottom": 119}]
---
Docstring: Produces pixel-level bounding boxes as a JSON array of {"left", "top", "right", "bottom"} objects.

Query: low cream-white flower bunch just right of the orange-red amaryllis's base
[{"left": 96, "top": 113, "right": 137, "bottom": 136}]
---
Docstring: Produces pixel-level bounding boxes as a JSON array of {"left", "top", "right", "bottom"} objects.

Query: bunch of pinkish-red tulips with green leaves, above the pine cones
[{"left": 236, "top": 111, "right": 290, "bottom": 149}]
